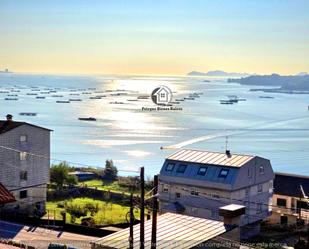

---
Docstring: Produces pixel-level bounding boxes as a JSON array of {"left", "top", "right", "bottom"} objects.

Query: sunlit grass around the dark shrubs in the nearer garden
[{"left": 44, "top": 198, "right": 139, "bottom": 225}]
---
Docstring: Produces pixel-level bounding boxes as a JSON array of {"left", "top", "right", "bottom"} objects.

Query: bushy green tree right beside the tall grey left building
[{"left": 50, "top": 162, "right": 77, "bottom": 189}]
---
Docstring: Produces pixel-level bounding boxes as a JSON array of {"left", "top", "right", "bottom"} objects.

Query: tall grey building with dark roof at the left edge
[{"left": 0, "top": 121, "right": 51, "bottom": 214}]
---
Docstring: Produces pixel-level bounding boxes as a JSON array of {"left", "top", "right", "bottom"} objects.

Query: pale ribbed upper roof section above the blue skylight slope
[{"left": 167, "top": 149, "right": 254, "bottom": 168}]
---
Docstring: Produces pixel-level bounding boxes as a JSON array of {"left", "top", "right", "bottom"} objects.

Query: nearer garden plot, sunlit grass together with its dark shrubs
[{"left": 44, "top": 198, "right": 139, "bottom": 225}]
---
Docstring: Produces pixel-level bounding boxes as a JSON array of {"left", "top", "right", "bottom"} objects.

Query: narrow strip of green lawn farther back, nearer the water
[{"left": 78, "top": 179, "right": 139, "bottom": 194}]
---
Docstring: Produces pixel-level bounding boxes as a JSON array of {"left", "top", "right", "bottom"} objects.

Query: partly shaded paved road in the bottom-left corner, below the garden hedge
[{"left": 0, "top": 221, "right": 98, "bottom": 249}]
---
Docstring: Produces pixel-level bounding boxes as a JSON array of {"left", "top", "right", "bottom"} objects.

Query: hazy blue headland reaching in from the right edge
[{"left": 228, "top": 74, "right": 309, "bottom": 94}]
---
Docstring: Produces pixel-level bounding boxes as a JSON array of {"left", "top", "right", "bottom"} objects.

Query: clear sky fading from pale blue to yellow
[{"left": 0, "top": 0, "right": 309, "bottom": 75}]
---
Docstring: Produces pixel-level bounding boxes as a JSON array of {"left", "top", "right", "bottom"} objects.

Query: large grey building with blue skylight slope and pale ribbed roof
[{"left": 159, "top": 149, "right": 274, "bottom": 225}]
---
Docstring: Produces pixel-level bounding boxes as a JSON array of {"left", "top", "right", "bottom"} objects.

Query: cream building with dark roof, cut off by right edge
[{"left": 269, "top": 173, "right": 309, "bottom": 225}]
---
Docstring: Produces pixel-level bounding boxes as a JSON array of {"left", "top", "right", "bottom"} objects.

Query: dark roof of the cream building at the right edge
[{"left": 274, "top": 172, "right": 309, "bottom": 197}]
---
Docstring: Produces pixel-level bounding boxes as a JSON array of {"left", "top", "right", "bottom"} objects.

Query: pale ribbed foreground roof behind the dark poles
[{"left": 95, "top": 213, "right": 228, "bottom": 249}]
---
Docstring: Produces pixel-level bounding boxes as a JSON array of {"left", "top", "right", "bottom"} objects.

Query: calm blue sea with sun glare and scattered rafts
[{"left": 0, "top": 73, "right": 309, "bottom": 178}]
